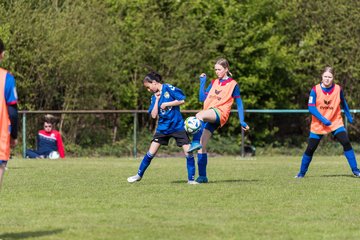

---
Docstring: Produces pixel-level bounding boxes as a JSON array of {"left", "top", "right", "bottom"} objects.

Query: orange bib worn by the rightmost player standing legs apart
[{"left": 310, "top": 84, "right": 344, "bottom": 134}]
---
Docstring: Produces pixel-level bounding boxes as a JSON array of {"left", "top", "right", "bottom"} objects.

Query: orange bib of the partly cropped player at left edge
[{"left": 0, "top": 68, "right": 10, "bottom": 161}]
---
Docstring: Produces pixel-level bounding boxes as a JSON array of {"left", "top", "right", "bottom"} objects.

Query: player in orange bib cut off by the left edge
[{"left": 0, "top": 39, "right": 18, "bottom": 190}]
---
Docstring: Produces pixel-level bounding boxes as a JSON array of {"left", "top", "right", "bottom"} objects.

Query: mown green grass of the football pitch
[{"left": 0, "top": 156, "right": 360, "bottom": 240}]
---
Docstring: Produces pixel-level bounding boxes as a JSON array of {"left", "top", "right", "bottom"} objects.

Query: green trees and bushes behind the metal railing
[{"left": 0, "top": 0, "right": 360, "bottom": 154}]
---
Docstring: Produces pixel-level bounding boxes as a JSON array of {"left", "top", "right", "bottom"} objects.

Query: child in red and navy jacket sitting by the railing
[{"left": 26, "top": 114, "right": 65, "bottom": 158}]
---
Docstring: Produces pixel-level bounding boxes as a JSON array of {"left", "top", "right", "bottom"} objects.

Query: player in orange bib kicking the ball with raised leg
[{"left": 188, "top": 58, "right": 249, "bottom": 183}]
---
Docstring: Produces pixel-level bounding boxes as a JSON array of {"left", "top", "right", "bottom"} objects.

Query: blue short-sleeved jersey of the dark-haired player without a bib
[{"left": 149, "top": 84, "right": 186, "bottom": 134}]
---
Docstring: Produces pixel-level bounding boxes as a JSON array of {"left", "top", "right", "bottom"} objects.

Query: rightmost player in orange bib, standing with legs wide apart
[{"left": 295, "top": 67, "right": 360, "bottom": 178}]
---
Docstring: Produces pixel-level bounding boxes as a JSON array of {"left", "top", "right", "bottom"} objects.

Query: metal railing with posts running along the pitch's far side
[{"left": 19, "top": 109, "right": 360, "bottom": 158}]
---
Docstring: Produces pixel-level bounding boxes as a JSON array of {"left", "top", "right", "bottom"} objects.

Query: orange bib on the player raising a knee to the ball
[{"left": 204, "top": 78, "right": 237, "bottom": 127}]
